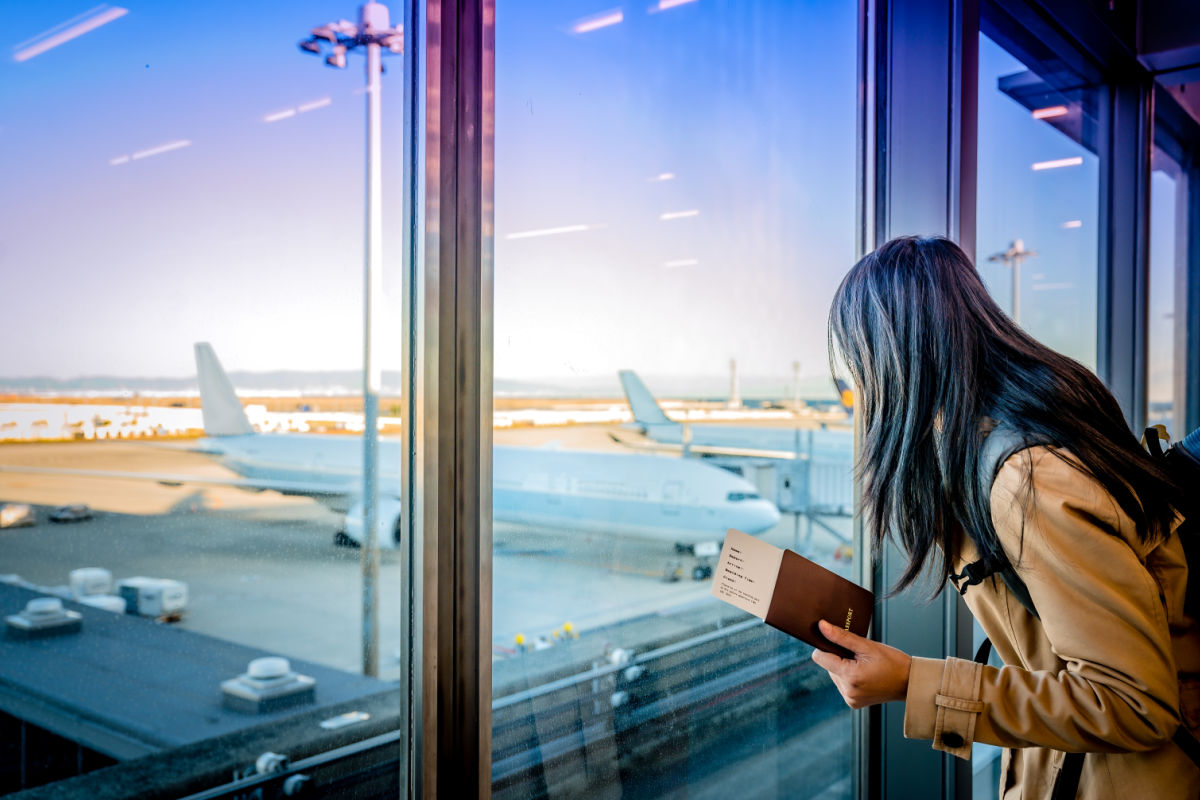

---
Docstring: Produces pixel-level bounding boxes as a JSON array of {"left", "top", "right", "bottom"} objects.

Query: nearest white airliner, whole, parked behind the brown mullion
[{"left": 0, "top": 342, "right": 780, "bottom": 551}]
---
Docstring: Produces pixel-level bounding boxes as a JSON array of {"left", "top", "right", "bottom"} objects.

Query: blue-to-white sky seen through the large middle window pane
[{"left": 496, "top": 0, "right": 857, "bottom": 388}]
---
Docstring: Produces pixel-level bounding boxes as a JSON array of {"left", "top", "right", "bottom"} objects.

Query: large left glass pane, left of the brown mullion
[{"left": 0, "top": 0, "right": 404, "bottom": 796}]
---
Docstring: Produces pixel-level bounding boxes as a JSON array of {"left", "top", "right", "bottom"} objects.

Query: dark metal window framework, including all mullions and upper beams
[{"left": 415, "top": 0, "right": 1200, "bottom": 798}]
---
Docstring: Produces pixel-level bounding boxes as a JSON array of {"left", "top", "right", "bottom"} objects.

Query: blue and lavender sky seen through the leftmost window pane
[{"left": 0, "top": 1, "right": 401, "bottom": 375}]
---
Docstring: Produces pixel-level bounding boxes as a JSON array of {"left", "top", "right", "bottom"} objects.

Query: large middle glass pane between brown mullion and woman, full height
[{"left": 493, "top": 0, "right": 857, "bottom": 798}]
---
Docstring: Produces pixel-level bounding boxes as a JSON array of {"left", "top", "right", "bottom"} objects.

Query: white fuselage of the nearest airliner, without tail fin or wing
[{"left": 200, "top": 434, "right": 779, "bottom": 543}]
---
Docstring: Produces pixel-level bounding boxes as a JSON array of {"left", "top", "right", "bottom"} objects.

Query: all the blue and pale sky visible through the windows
[{"left": 0, "top": 0, "right": 1161, "bottom": 398}]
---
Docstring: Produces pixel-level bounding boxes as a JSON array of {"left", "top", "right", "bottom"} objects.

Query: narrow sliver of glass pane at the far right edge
[{"left": 1146, "top": 148, "right": 1187, "bottom": 439}]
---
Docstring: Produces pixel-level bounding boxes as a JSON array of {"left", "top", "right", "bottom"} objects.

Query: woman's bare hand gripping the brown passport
[{"left": 812, "top": 620, "right": 912, "bottom": 709}]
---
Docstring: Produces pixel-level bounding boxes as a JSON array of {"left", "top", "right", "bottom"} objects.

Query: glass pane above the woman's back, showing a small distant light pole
[{"left": 977, "top": 35, "right": 1099, "bottom": 369}]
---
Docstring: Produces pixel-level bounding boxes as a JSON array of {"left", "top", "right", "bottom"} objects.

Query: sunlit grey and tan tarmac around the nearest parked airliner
[{"left": 0, "top": 438, "right": 854, "bottom": 680}]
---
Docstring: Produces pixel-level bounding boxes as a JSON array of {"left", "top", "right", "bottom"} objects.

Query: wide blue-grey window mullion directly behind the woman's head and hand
[{"left": 860, "top": 0, "right": 979, "bottom": 798}]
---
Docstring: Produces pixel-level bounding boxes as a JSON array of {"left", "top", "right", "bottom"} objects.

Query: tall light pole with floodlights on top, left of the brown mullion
[{"left": 300, "top": 2, "right": 404, "bottom": 676}]
